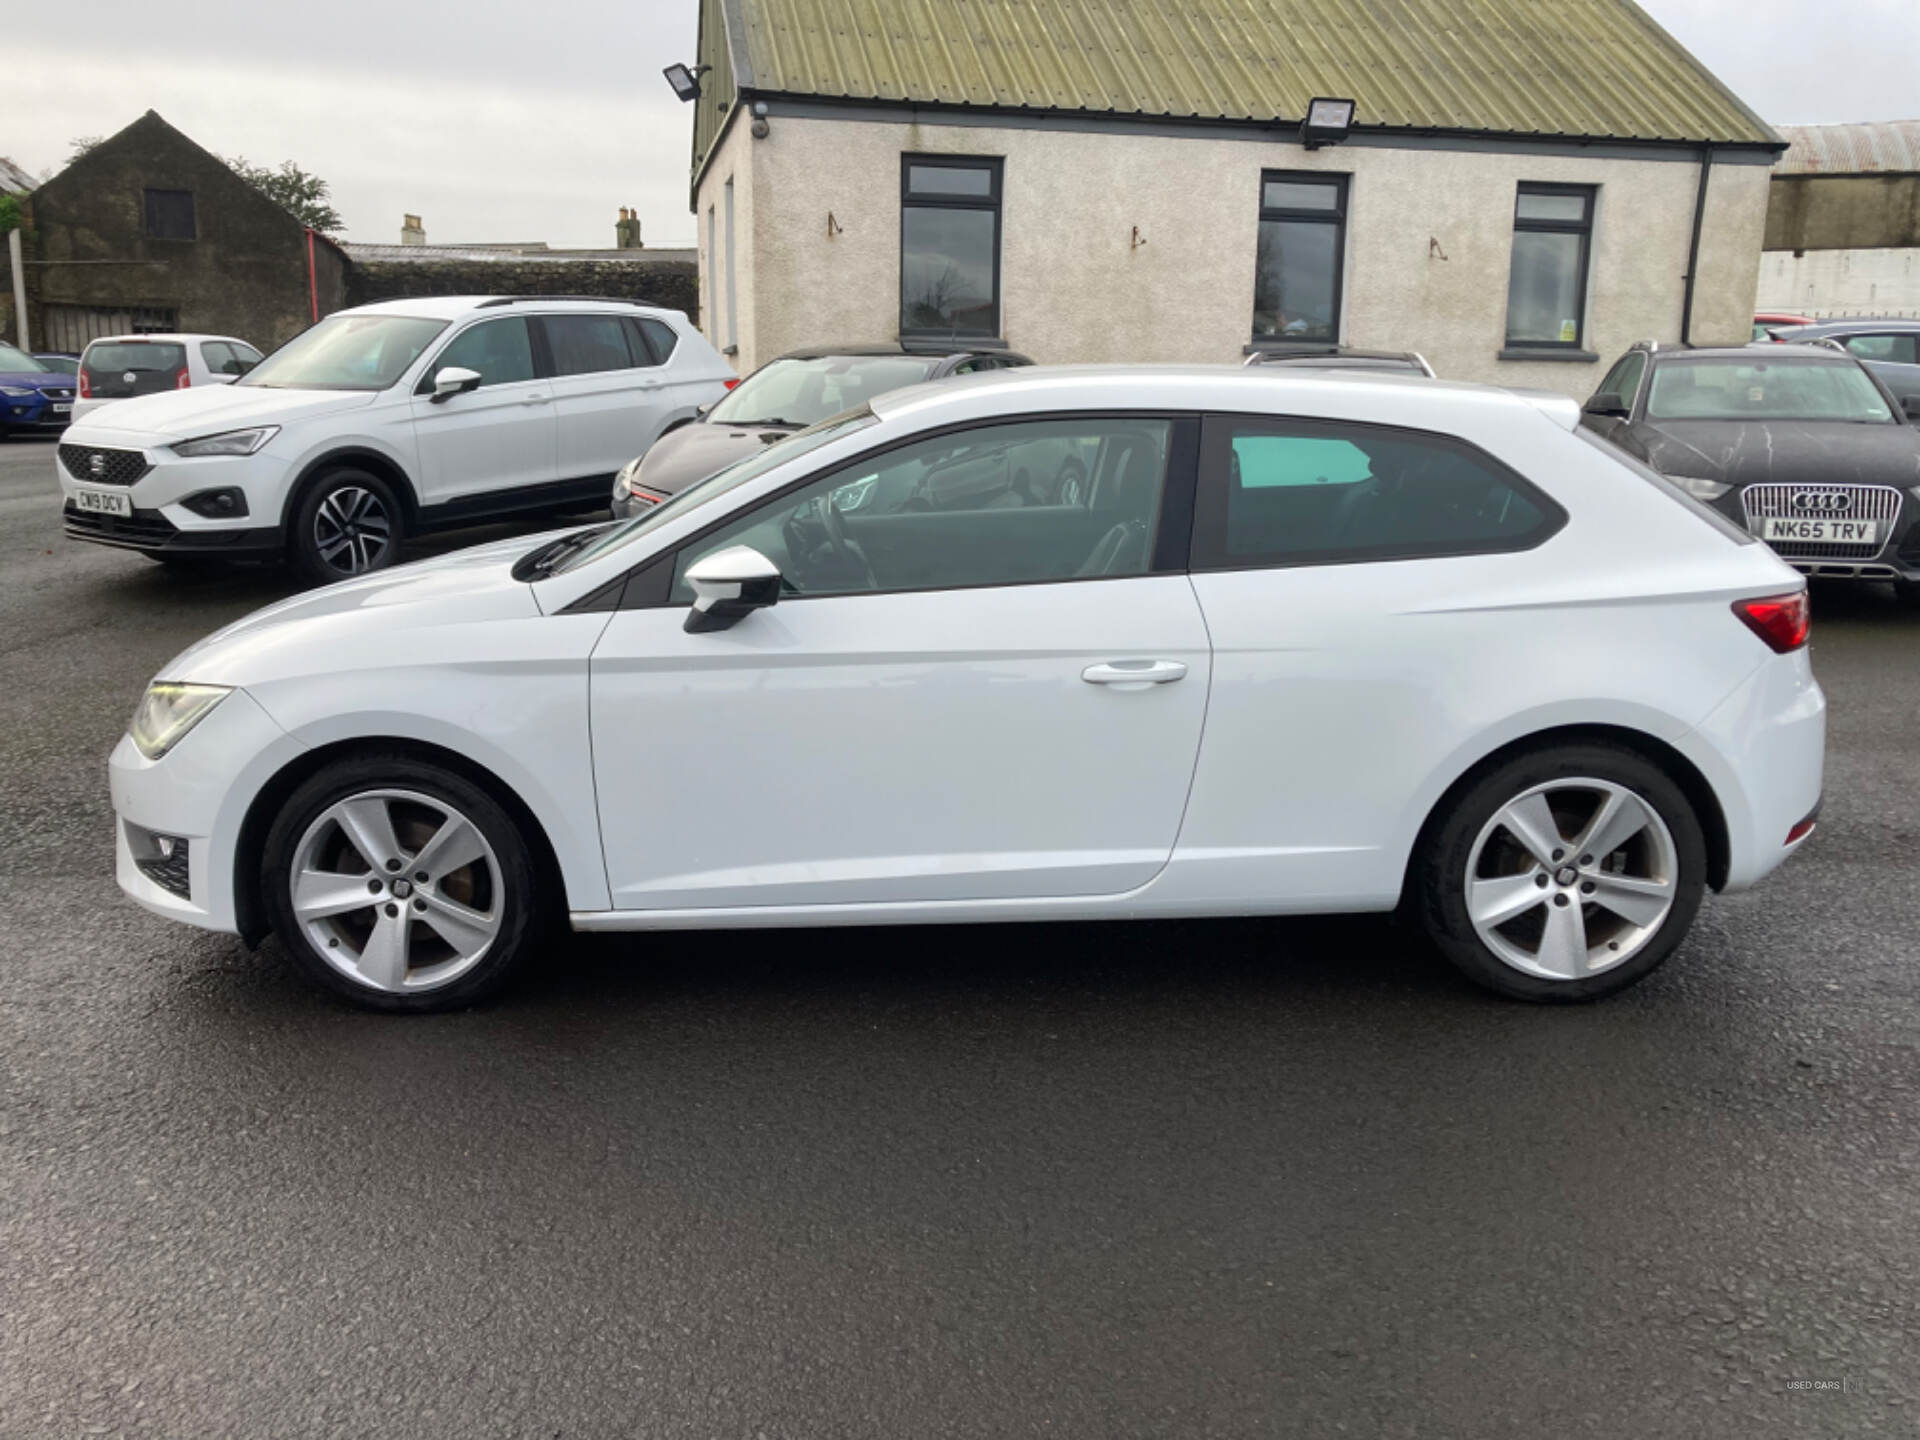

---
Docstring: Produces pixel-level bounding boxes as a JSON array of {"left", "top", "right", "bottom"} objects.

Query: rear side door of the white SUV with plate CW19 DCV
[{"left": 540, "top": 315, "right": 672, "bottom": 486}]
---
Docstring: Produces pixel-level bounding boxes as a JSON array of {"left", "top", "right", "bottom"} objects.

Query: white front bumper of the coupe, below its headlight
[{"left": 108, "top": 689, "right": 305, "bottom": 933}]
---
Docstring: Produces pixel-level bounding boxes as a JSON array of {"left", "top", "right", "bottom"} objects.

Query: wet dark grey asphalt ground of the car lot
[{"left": 0, "top": 442, "right": 1920, "bottom": 1440}]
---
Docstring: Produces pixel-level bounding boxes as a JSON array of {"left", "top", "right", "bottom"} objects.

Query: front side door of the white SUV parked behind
[{"left": 411, "top": 315, "right": 555, "bottom": 505}]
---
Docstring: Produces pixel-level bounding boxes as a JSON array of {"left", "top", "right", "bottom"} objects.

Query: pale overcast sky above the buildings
[{"left": 0, "top": 0, "right": 1920, "bottom": 246}]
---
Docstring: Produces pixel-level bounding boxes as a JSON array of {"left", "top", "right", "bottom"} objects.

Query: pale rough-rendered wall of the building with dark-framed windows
[{"left": 697, "top": 111, "right": 1770, "bottom": 397}]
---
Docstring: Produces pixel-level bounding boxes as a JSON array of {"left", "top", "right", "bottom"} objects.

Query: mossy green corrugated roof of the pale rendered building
[{"left": 725, "top": 0, "right": 1778, "bottom": 144}]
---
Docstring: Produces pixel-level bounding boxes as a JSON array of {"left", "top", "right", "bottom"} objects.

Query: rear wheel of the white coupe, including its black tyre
[{"left": 1411, "top": 743, "right": 1707, "bottom": 1002}]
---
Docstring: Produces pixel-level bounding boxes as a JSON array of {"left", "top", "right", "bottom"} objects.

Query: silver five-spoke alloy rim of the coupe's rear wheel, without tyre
[{"left": 1467, "top": 780, "right": 1680, "bottom": 979}]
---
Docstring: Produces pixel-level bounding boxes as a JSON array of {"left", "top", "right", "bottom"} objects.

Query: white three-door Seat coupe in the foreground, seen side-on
[{"left": 111, "top": 367, "right": 1826, "bottom": 1010}]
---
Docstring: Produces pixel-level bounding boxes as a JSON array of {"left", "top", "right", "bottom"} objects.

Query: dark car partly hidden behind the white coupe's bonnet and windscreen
[{"left": 612, "top": 344, "right": 1033, "bottom": 518}]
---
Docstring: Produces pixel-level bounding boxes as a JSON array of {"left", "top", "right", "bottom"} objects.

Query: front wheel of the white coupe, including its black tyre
[{"left": 261, "top": 755, "right": 549, "bottom": 1014}]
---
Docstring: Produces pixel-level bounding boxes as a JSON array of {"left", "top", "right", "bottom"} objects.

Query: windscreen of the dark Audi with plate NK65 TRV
[{"left": 1647, "top": 357, "right": 1893, "bottom": 424}]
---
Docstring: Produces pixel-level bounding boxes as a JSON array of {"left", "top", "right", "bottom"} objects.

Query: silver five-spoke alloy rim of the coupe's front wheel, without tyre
[{"left": 288, "top": 789, "right": 507, "bottom": 995}]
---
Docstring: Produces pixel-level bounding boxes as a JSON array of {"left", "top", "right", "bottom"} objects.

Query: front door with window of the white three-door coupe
[{"left": 591, "top": 417, "right": 1212, "bottom": 910}]
